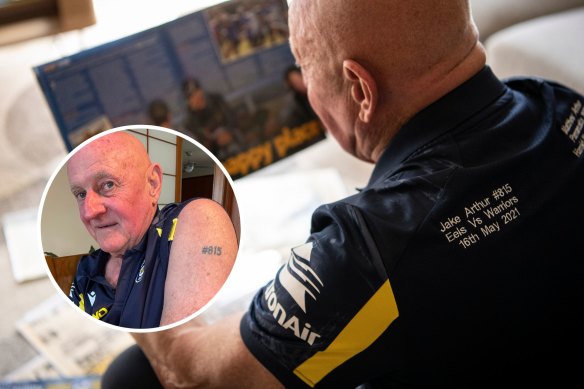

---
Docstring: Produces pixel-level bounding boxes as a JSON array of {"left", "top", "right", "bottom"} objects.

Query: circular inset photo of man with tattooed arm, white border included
[{"left": 39, "top": 126, "right": 240, "bottom": 331}]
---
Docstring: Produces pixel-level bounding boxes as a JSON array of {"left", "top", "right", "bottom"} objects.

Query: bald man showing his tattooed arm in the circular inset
[{"left": 67, "top": 132, "right": 237, "bottom": 328}]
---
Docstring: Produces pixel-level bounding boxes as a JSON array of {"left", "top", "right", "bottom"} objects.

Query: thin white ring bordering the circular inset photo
[{"left": 37, "top": 124, "right": 244, "bottom": 333}]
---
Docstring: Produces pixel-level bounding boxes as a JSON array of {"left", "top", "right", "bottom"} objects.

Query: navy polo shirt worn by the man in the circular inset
[{"left": 69, "top": 202, "right": 187, "bottom": 328}]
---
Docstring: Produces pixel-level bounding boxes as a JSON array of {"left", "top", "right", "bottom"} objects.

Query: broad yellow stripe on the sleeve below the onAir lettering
[{"left": 294, "top": 280, "right": 399, "bottom": 387}]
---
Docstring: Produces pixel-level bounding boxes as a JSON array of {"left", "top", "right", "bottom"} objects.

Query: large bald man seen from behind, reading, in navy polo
[{"left": 110, "top": 0, "right": 584, "bottom": 388}]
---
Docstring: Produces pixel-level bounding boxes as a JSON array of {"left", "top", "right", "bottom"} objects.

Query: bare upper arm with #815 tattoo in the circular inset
[{"left": 160, "top": 199, "right": 237, "bottom": 326}]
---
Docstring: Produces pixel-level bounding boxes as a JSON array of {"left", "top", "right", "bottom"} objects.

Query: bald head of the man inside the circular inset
[{"left": 67, "top": 132, "right": 162, "bottom": 255}]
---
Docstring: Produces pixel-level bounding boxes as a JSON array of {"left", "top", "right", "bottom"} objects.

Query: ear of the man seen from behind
[{"left": 343, "top": 59, "right": 379, "bottom": 123}]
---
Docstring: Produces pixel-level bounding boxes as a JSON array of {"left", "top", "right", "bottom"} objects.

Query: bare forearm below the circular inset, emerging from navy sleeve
[{"left": 133, "top": 314, "right": 282, "bottom": 388}]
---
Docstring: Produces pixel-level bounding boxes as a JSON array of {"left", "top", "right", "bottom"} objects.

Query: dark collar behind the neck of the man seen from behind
[{"left": 368, "top": 66, "right": 506, "bottom": 185}]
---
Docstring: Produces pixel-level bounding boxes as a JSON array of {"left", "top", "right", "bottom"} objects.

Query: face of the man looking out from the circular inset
[{"left": 67, "top": 144, "right": 153, "bottom": 255}]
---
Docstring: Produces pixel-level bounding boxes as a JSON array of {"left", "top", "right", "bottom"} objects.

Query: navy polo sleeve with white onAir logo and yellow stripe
[{"left": 240, "top": 203, "right": 398, "bottom": 387}]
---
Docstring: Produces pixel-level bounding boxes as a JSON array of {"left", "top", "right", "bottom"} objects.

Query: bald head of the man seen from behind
[{"left": 289, "top": 0, "right": 485, "bottom": 161}]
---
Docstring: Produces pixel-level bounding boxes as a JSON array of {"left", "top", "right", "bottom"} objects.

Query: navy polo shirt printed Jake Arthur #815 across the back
[{"left": 240, "top": 67, "right": 584, "bottom": 388}]
